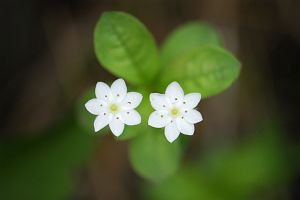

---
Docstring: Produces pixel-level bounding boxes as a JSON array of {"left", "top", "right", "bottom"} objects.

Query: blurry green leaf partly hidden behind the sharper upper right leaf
[{"left": 161, "top": 22, "right": 220, "bottom": 67}]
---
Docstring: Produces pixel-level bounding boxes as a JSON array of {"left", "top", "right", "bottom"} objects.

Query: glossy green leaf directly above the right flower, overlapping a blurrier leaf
[{"left": 162, "top": 46, "right": 240, "bottom": 98}]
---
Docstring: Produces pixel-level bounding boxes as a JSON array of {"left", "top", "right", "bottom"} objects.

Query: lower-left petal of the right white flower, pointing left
[{"left": 148, "top": 111, "right": 171, "bottom": 128}]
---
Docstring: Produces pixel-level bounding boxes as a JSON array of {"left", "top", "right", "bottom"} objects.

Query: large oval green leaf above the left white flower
[{"left": 94, "top": 12, "right": 159, "bottom": 85}]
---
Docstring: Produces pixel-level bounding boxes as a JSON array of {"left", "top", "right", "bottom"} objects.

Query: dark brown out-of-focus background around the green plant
[{"left": 0, "top": 0, "right": 300, "bottom": 200}]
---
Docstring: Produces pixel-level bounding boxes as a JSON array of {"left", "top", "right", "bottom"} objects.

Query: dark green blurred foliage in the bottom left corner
[{"left": 0, "top": 117, "right": 95, "bottom": 200}]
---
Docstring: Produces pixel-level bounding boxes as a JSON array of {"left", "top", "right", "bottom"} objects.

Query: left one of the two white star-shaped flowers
[{"left": 85, "top": 79, "right": 143, "bottom": 137}]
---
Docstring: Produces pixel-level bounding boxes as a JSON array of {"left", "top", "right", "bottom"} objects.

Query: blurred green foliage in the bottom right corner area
[{"left": 144, "top": 125, "right": 292, "bottom": 200}]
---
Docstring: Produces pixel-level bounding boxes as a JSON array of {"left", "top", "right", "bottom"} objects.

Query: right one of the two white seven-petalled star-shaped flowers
[{"left": 148, "top": 82, "right": 203, "bottom": 142}]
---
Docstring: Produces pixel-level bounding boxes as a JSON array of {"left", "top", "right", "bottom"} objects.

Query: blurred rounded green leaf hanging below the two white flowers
[{"left": 130, "top": 128, "right": 181, "bottom": 182}]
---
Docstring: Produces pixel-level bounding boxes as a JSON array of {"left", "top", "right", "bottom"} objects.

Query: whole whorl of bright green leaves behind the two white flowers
[{"left": 94, "top": 12, "right": 240, "bottom": 181}]
